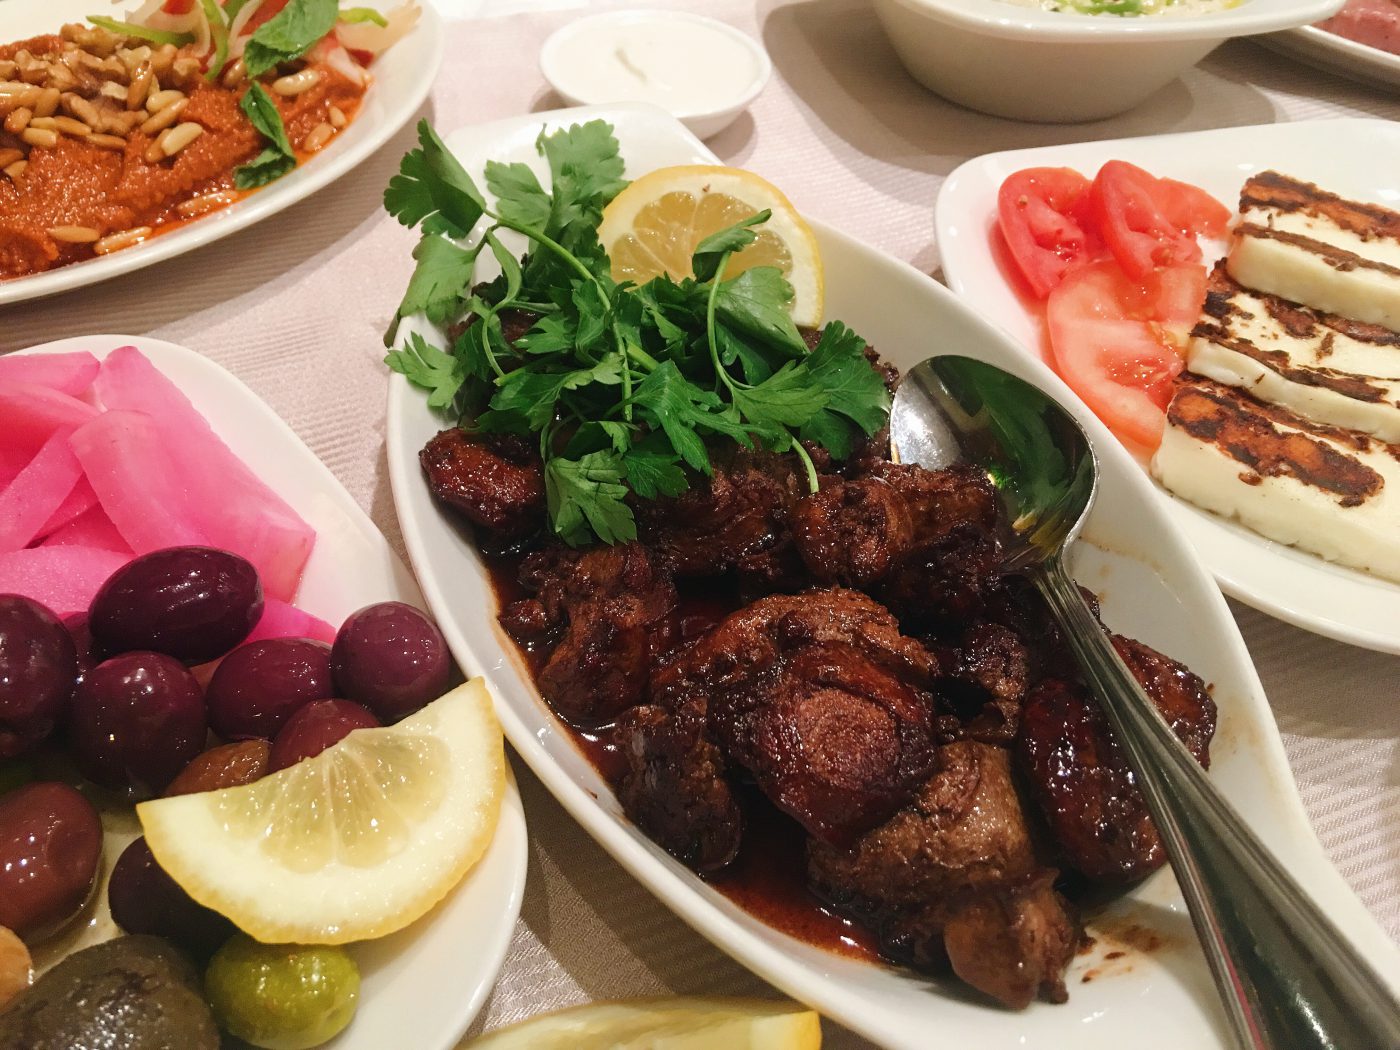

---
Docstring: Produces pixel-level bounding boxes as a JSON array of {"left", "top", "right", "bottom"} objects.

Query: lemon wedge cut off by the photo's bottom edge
[{"left": 466, "top": 998, "right": 822, "bottom": 1050}]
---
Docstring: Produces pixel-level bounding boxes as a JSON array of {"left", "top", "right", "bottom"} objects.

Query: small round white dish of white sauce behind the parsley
[{"left": 539, "top": 11, "right": 773, "bottom": 139}]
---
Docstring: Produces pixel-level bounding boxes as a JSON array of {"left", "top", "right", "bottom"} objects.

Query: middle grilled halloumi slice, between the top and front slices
[{"left": 1186, "top": 265, "right": 1400, "bottom": 442}]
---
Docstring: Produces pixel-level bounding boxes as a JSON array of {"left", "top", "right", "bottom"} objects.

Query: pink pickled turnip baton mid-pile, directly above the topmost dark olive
[{"left": 70, "top": 412, "right": 214, "bottom": 554}]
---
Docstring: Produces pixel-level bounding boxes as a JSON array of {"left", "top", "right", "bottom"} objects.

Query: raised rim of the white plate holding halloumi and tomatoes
[{"left": 934, "top": 116, "right": 1400, "bottom": 655}]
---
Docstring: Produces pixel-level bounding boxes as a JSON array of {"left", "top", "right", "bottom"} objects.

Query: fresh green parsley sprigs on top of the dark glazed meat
[{"left": 384, "top": 120, "right": 889, "bottom": 545}]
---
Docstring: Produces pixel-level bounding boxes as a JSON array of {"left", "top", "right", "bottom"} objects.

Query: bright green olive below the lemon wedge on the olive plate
[{"left": 204, "top": 934, "right": 360, "bottom": 1050}]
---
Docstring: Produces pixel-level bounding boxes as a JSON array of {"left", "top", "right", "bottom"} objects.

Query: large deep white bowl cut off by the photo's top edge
[{"left": 874, "top": 0, "right": 1343, "bottom": 123}]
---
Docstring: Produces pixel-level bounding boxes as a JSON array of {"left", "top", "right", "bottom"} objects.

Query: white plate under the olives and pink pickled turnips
[{"left": 10, "top": 336, "right": 526, "bottom": 1050}]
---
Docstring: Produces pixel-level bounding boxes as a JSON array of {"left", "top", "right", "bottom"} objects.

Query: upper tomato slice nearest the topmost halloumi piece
[{"left": 1089, "top": 161, "right": 1201, "bottom": 277}]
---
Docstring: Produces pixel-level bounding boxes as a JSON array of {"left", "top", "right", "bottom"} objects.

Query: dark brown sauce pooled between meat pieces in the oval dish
[{"left": 482, "top": 553, "right": 881, "bottom": 962}]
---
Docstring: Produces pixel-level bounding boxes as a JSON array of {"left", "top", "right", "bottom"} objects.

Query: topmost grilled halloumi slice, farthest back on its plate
[{"left": 1228, "top": 171, "right": 1400, "bottom": 329}]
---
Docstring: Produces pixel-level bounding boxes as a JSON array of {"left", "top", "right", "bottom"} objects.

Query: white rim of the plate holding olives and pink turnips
[{"left": 9, "top": 333, "right": 529, "bottom": 1050}]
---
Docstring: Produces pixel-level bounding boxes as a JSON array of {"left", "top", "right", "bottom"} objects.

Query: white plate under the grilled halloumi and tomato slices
[{"left": 934, "top": 119, "right": 1400, "bottom": 652}]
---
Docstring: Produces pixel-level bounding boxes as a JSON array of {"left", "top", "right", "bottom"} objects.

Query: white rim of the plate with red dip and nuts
[{"left": 0, "top": 0, "right": 447, "bottom": 308}]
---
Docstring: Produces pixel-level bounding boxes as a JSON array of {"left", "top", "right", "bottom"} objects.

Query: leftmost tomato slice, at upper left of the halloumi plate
[{"left": 997, "top": 168, "right": 1098, "bottom": 298}]
